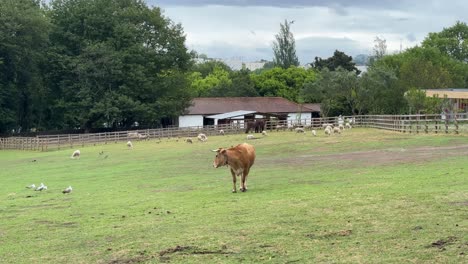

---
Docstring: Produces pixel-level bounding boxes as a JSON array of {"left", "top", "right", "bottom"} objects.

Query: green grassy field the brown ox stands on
[{"left": 0, "top": 129, "right": 468, "bottom": 263}]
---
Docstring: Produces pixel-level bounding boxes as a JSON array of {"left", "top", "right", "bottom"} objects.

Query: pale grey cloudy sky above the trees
[{"left": 146, "top": 0, "right": 468, "bottom": 64}]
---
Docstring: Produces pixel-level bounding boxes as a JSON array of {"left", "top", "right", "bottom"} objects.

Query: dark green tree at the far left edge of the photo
[{"left": 0, "top": 0, "right": 50, "bottom": 132}]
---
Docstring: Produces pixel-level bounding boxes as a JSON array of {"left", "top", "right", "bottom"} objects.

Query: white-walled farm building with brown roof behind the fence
[{"left": 178, "top": 97, "right": 320, "bottom": 127}]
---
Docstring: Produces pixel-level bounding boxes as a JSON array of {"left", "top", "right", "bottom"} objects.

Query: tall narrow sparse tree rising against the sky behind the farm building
[{"left": 273, "top": 20, "right": 299, "bottom": 69}]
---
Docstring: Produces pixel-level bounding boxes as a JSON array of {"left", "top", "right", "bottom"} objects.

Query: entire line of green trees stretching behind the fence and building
[{"left": 0, "top": 0, "right": 468, "bottom": 134}]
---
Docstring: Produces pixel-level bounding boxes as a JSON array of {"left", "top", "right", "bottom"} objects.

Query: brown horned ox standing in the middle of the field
[{"left": 213, "top": 143, "right": 255, "bottom": 192}]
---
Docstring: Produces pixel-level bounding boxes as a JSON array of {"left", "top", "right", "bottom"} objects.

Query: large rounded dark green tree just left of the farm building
[{"left": 48, "top": 0, "right": 191, "bottom": 128}]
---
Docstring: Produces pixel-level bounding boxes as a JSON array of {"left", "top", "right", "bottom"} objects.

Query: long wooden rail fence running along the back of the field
[{"left": 0, "top": 113, "right": 468, "bottom": 151}]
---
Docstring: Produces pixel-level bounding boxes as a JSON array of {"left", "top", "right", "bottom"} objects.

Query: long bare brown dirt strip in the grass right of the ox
[{"left": 259, "top": 145, "right": 468, "bottom": 168}]
